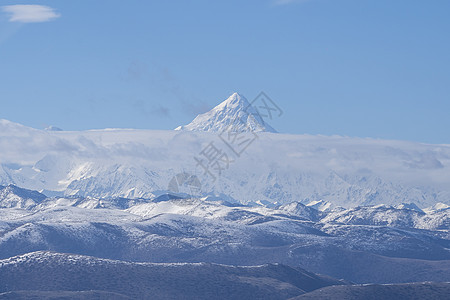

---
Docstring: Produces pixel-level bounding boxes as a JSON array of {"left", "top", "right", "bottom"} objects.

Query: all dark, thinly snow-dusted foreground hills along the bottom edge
[{"left": 0, "top": 251, "right": 450, "bottom": 300}]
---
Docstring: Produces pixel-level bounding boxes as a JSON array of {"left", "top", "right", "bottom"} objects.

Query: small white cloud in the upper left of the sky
[{"left": 2, "top": 5, "right": 61, "bottom": 23}]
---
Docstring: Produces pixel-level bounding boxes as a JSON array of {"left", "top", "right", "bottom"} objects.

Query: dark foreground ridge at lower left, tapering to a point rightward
[{"left": 0, "top": 252, "right": 343, "bottom": 299}]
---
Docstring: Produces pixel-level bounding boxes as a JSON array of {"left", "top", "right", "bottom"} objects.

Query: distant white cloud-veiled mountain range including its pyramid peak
[{"left": 0, "top": 94, "right": 450, "bottom": 209}]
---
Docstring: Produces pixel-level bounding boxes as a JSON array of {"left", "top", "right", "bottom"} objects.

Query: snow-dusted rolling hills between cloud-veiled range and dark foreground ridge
[{"left": 0, "top": 186, "right": 450, "bottom": 283}]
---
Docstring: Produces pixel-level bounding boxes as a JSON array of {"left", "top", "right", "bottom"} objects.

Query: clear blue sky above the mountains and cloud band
[{"left": 0, "top": 0, "right": 450, "bottom": 144}]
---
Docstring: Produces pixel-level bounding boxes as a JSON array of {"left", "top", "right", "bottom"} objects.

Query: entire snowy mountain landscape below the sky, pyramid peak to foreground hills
[{"left": 0, "top": 94, "right": 450, "bottom": 299}]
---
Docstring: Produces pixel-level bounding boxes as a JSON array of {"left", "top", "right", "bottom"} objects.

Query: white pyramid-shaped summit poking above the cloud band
[{"left": 175, "top": 93, "right": 277, "bottom": 132}]
